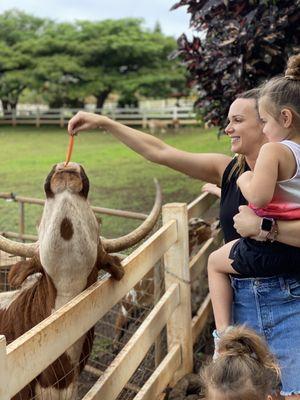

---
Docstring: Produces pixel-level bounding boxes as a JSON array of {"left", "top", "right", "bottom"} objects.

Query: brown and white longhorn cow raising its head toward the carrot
[{"left": 0, "top": 163, "right": 161, "bottom": 400}]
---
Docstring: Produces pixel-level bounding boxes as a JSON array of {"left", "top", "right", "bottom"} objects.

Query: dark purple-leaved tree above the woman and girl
[{"left": 172, "top": 0, "right": 300, "bottom": 126}]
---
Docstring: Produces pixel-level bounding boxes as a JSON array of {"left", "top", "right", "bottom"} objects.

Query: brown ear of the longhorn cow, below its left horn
[{"left": 8, "top": 258, "right": 43, "bottom": 288}]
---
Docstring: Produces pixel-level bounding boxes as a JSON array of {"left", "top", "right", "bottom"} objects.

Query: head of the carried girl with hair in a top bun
[{"left": 259, "top": 54, "right": 300, "bottom": 141}]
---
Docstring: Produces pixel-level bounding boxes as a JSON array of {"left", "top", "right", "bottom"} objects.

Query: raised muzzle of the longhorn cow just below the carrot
[{"left": 44, "top": 162, "right": 90, "bottom": 198}]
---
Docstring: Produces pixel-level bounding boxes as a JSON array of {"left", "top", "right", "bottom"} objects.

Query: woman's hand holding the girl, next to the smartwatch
[{"left": 233, "top": 206, "right": 261, "bottom": 239}]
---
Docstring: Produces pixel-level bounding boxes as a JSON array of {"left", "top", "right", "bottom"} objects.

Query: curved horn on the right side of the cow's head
[{"left": 101, "top": 179, "right": 162, "bottom": 253}]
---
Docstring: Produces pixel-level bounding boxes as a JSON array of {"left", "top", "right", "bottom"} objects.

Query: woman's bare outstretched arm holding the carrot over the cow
[{"left": 68, "top": 111, "right": 231, "bottom": 185}]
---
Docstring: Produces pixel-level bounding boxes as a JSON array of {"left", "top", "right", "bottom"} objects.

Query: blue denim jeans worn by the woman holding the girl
[{"left": 231, "top": 276, "right": 300, "bottom": 396}]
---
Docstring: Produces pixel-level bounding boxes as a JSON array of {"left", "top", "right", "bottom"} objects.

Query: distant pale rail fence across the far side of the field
[{"left": 0, "top": 107, "right": 198, "bottom": 128}]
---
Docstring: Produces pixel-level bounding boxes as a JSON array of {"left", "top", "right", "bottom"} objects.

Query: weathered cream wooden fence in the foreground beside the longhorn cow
[{"left": 0, "top": 194, "right": 222, "bottom": 400}]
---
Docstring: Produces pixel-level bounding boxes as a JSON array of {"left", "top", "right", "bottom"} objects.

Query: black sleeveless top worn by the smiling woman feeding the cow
[{"left": 220, "top": 158, "right": 250, "bottom": 243}]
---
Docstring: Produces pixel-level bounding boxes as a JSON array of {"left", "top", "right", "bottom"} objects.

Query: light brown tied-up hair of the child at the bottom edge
[{"left": 200, "top": 326, "right": 280, "bottom": 400}]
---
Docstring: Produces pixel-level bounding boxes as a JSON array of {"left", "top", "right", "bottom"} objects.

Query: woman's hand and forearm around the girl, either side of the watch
[{"left": 233, "top": 206, "right": 300, "bottom": 247}]
